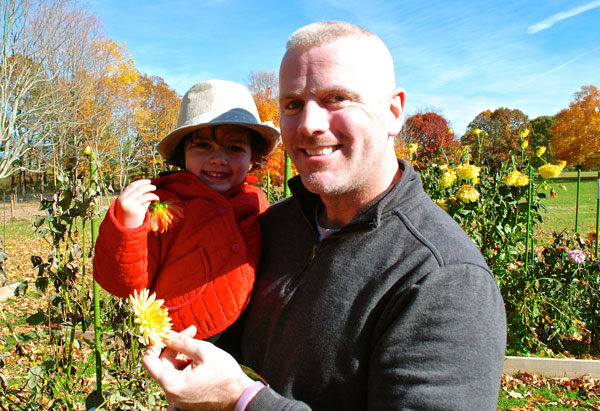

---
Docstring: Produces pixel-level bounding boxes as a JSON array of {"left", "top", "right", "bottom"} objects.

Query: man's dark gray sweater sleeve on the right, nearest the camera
[{"left": 368, "top": 264, "right": 506, "bottom": 411}]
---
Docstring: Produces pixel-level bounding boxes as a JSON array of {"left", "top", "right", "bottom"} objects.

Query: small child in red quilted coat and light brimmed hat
[{"left": 94, "top": 80, "right": 279, "bottom": 339}]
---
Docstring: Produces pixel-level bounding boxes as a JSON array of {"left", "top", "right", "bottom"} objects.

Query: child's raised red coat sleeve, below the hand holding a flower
[{"left": 94, "top": 200, "right": 159, "bottom": 298}]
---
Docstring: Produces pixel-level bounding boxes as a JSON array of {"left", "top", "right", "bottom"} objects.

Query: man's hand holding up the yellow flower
[{"left": 142, "top": 326, "right": 253, "bottom": 410}]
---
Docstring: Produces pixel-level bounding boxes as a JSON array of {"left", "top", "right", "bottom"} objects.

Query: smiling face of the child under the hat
[{"left": 185, "top": 125, "right": 252, "bottom": 194}]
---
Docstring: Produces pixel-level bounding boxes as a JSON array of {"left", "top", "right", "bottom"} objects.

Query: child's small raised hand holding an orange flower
[{"left": 115, "top": 180, "right": 159, "bottom": 228}]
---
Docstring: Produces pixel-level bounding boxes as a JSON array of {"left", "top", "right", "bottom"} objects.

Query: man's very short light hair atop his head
[{"left": 286, "top": 21, "right": 382, "bottom": 50}]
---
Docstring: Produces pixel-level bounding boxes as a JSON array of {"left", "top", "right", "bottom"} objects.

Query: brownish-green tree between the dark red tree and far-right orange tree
[{"left": 460, "top": 107, "right": 530, "bottom": 168}]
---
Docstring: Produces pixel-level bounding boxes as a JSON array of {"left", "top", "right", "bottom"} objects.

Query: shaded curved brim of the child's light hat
[{"left": 156, "top": 112, "right": 281, "bottom": 166}]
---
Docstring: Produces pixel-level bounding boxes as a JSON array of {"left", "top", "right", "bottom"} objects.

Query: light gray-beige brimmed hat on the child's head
[{"left": 157, "top": 80, "right": 280, "bottom": 161}]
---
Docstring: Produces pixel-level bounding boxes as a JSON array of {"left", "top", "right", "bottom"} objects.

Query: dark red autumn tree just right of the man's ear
[{"left": 399, "top": 112, "right": 460, "bottom": 164}]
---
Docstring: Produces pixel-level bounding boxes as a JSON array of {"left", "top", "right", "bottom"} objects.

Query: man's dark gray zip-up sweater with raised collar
[{"left": 242, "top": 160, "right": 506, "bottom": 411}]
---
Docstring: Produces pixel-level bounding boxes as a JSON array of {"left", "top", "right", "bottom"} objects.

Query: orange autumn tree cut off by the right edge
[{"left": 550, "top": 85, "right": 600, "bottom": 169}]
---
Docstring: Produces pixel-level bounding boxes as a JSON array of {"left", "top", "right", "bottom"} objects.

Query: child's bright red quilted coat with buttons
[{"left": 94, "top": 172, "right": 268, "bottom": 339}]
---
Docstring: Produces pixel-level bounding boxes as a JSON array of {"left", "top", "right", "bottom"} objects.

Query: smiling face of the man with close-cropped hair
[{"left": 279, "top": 39, "right": 404, "bottom": 198}]
